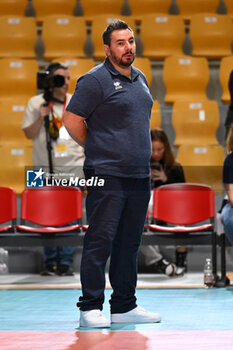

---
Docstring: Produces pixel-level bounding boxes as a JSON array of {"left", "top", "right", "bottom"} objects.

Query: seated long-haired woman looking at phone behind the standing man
[{"left": 139, "top": 128, "right": 187, "bottom": 276}]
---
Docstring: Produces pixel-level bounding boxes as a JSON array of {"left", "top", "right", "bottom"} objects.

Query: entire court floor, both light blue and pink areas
[{"left": 0, "top": 288, "right": 233, "bottom": 350}]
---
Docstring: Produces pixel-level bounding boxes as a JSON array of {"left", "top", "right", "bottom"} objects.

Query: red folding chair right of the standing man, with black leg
[{"left": 148, "top": 183, "right": 217, "bottom": 280}]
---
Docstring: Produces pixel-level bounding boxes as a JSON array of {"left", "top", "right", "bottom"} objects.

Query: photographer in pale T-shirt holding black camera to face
[{"left": 22, "top": 62, "right": 84, "bottom": 276}]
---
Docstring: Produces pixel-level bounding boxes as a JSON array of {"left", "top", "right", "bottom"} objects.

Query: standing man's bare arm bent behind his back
[{"left": 63, "top": 110, "right": 87, "bottom": 147}]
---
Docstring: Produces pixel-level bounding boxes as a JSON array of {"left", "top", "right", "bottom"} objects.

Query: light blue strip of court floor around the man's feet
[{"left": 0, "top": 288, "right": 233, "bottom": 330}]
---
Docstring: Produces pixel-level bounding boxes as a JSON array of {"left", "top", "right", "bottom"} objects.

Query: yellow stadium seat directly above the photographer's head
[{"left": 42, "top": 15, "right": 87, "bottom": 60}]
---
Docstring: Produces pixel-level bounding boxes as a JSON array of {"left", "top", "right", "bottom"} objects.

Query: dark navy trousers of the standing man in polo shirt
[{"left": 77, "top": 172, "right": 150, "bottom": 313}]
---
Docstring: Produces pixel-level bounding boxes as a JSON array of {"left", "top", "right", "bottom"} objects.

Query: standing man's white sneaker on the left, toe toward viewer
[{"left": 79, "top": 309, "right": 110, "bottom": 328}]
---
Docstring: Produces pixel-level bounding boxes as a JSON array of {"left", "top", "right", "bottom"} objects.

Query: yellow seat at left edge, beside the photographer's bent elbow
[{"left": 0, "top": 109, "right": 32, "bottom": 145}]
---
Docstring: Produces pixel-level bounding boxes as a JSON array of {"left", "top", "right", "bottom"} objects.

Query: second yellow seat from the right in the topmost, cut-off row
[{"left": 176, "top": 0, "right": 220, "bottom": 23}]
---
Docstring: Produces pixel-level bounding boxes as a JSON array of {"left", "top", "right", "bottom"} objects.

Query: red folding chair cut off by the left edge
[{"left": 0, "top": 186, "right": 17, "bottom": 233}]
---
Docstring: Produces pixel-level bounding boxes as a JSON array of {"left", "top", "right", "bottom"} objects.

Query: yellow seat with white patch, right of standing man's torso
[{"left": 172, "top": 101, "right": 220, "bottom": 147}]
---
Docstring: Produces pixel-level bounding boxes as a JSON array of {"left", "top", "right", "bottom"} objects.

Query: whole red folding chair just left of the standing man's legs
[{"left": 17, "top": 186, "right": 82, "bottom": 234}]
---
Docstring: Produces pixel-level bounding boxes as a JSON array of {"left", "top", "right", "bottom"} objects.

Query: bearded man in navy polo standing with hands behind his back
[{"left": 64, "top": 20, "right": 160, "bottom": 327}]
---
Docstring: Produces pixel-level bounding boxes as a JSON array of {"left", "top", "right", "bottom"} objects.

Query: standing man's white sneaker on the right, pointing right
[{"left": 111, "top": 306, "right": 161, "bottom": 323}]
